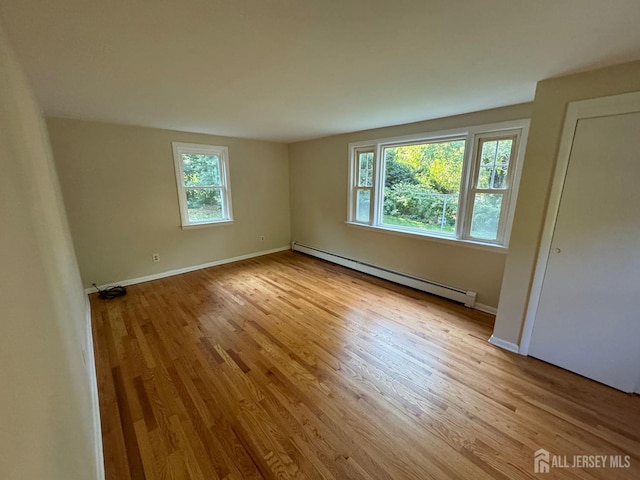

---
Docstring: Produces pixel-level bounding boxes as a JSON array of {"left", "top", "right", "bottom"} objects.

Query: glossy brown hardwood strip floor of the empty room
[{"left": 91, "top": 252, "right": 640, "bottom": 480}]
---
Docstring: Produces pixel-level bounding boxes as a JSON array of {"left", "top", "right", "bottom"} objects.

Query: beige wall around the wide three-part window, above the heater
[{"left": 289, "top": 104, "right": 531, "bottom": 307}]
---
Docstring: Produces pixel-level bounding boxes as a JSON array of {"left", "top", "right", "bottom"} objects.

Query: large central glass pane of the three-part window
[{"left": 382, "top": 140, "right": 465, "bottom": 235}]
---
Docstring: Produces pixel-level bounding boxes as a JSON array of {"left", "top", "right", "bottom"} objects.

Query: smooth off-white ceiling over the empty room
[{"left": 0, "top": 0, "right": 640, "bottom": 141}]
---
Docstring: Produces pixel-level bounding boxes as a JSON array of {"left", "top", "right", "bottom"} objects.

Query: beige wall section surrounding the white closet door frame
[{"left": 494, "top": 62, "right": 640, "bottom": 344}]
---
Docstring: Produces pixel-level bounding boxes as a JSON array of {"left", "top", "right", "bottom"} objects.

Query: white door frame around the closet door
[{"left": 518, "top": 92, "right": 640, "bottom": 356}]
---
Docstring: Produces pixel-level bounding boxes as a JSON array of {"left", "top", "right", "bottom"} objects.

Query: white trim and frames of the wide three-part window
[{"left": 346, "top": 119, "right": 530, "bottom": 251}]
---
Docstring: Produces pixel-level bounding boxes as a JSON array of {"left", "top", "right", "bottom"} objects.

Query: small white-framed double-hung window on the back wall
[{"left": 172, "top": 142, "right": 233, "bottom": 227}]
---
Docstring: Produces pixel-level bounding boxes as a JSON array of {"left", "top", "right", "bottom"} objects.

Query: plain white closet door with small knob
[{"left": 529, "top": 113, "right": 640, "bottom": 392}]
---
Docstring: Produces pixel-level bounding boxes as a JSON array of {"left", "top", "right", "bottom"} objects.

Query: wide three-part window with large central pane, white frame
[{"left": 348, "top": 120, "right": 528, "bottom": 246}]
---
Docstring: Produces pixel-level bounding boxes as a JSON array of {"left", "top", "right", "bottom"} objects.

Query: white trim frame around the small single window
[{"left": 171, "top": 142, "right": 233, "bottom": 229}]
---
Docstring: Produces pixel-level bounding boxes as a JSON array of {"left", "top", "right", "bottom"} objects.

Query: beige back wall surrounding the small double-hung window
[{"left": 47, "top": 118, "right": 289, "bottom": 287}]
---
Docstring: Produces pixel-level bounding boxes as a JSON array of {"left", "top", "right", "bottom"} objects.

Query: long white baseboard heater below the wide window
[{"left": 291, "top": 242, "right": 476, "bottom": 308}]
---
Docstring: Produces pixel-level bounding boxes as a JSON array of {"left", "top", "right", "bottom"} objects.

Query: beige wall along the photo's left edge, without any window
[{"left": 0, "top": 25, "right": 101, "bottom": 480}]
